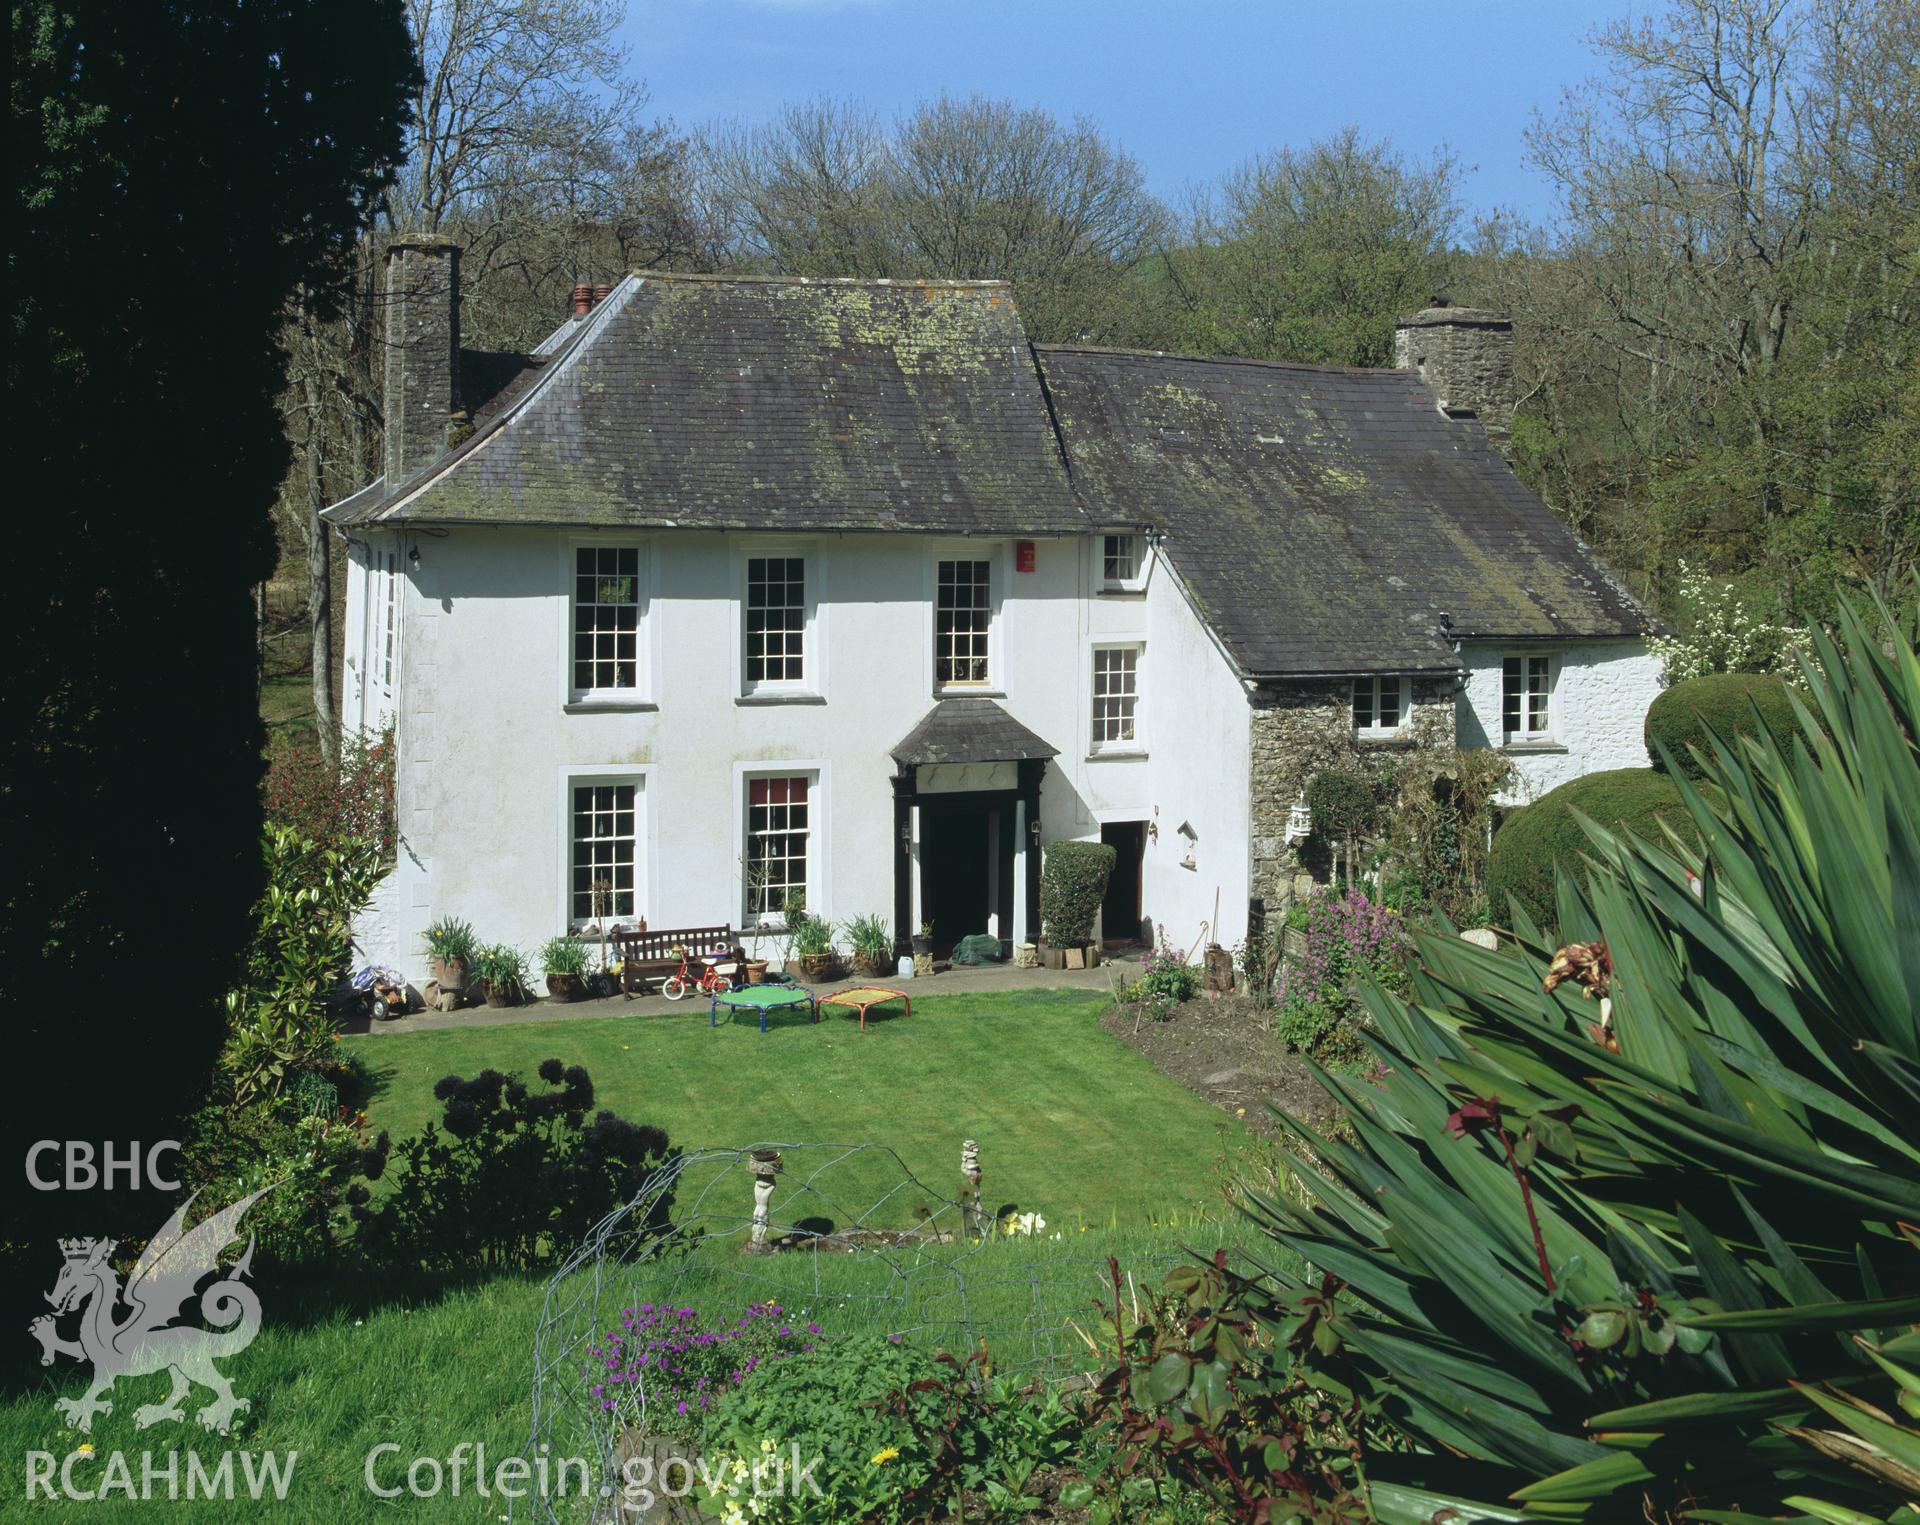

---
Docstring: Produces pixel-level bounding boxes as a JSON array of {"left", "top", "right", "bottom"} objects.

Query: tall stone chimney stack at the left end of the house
[{"left": 384, "top": 234, "right": 461, "bottom": 490}]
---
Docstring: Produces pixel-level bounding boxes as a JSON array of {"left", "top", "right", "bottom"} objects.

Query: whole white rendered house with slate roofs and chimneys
[{"left": 328, "top": 240, "right": 1657, "bottom": 972}]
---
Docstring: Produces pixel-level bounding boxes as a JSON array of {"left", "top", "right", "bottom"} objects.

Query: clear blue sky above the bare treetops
[{"left": 624, "top": 0, "right": 1628, "bottom": 217}]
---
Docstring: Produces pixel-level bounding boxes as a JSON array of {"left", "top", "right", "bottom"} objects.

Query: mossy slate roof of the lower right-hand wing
[{"left": 1037, "top": 346, "right": 1655, "bottom": 676}]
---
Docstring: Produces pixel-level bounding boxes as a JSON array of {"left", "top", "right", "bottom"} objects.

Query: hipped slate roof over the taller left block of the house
[{"left": 330, "top": 273, "right": 1089, "bottom": 534}]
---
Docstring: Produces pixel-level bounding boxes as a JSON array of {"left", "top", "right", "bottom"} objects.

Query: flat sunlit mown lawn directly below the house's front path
[{"left": 348, "top": 991, "right": 1225, "bottom": 1231}]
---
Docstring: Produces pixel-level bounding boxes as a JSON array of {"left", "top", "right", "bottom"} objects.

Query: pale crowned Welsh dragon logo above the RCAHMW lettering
[{"left": 27, "top": 1187, "right": 271, "bottom": 1435}]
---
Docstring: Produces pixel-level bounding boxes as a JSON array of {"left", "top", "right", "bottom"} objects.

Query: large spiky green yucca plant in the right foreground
[{"left": 1250, "top": 611, "right": 1920, "bottom": 1525}]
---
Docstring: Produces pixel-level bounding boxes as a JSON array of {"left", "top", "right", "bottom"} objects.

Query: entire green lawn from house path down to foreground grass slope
[{"left": 0, "top": 991, "right": 1250, "bottom": 1521}]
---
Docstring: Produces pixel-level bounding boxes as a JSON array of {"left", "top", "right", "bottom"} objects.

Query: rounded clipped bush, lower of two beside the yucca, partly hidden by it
[{"left": 1486, "top": 768, "right": 1688, "bottom": 926}]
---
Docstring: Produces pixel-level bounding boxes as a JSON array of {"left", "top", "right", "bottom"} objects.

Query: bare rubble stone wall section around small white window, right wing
[{"left": 1248, "top": 674, "right": 1455, "bottom": 916}]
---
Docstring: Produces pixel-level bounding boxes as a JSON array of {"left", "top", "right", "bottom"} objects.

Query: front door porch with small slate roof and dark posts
[{"left": 891, "top": 699, "right": 1060, "bottom": 956}]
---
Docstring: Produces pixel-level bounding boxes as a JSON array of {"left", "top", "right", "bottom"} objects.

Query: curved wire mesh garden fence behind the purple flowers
[{"left": 515, "top": 1141, "right": 1185, "bottom": 1521}]
